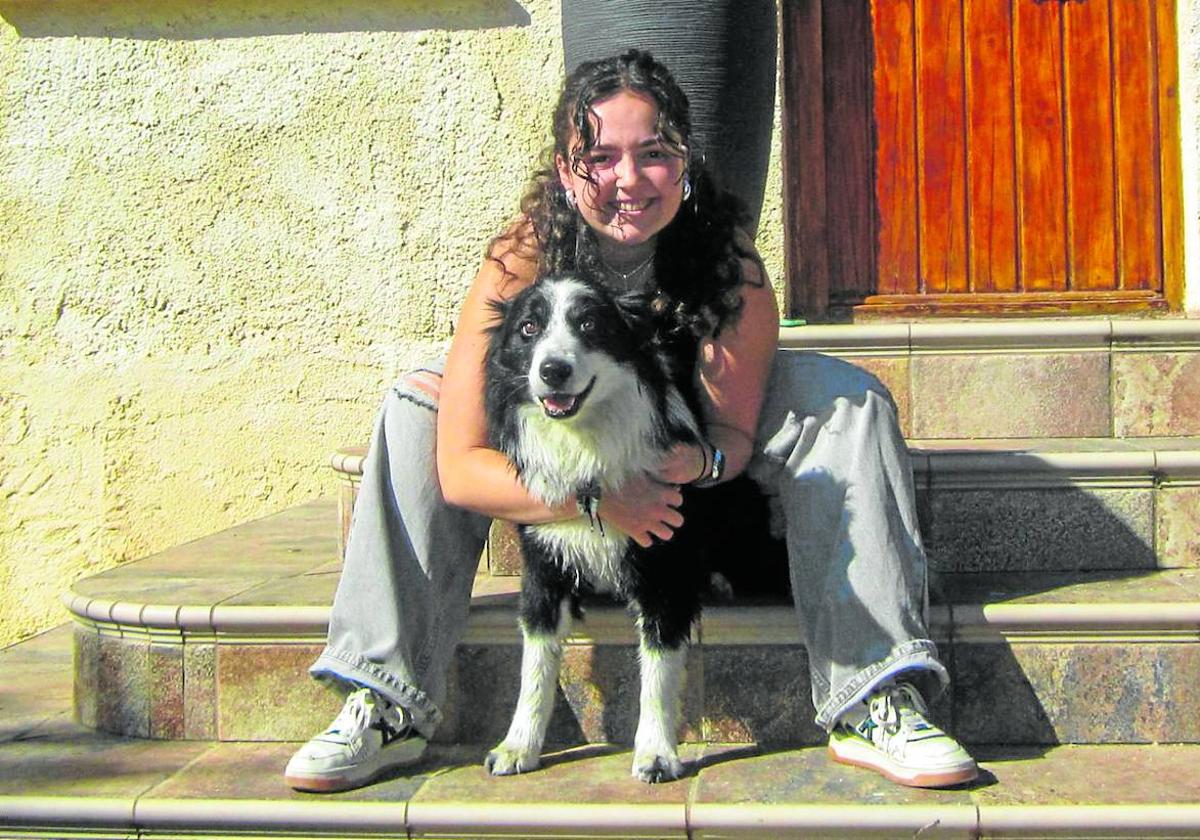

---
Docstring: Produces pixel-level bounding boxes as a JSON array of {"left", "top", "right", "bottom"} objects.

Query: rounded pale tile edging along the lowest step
[{"left": 7, "top": 797, "right": 1200, "bottom": 839}]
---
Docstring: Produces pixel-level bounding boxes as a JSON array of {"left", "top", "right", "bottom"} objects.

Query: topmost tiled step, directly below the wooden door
[{"left": 780, "top": 318, "right": 1200, "bottom": 439}]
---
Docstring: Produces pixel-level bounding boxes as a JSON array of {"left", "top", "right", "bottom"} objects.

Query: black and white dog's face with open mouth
[{"left": 488, "top": 276, "right": 653, "bottom": 420}]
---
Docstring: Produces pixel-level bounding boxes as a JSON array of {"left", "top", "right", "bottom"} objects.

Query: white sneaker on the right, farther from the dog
[{"left": 829, "top": 683, "right": 979, "bottom": 787}]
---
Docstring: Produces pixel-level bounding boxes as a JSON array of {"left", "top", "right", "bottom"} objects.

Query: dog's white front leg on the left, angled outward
[{"left": 484, "top": 599, "right": 571, "bottom": 776}]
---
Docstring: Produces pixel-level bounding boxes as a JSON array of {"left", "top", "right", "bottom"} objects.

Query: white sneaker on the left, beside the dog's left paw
[{"left": 283, "top": 689, "right": 426, "bottom": 793}]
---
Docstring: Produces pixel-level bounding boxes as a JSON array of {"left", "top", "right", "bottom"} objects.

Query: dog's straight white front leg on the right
[{"left": 632, "top": 628, "right": 688, "bottom": 784}]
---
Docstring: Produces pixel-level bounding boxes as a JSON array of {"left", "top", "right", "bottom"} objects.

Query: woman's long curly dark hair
[{"left": 487, "top": 49, "right": 763, "bottom": 346}]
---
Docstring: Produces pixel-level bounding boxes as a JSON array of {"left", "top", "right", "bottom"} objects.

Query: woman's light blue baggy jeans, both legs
[{"left": 310, "top": 350, "right": 949, "bottom": 736}]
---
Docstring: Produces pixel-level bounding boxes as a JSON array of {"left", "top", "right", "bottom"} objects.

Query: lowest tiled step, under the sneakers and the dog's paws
[{"left": 0, "top": 625, "right": 1200, "bottom": 840}]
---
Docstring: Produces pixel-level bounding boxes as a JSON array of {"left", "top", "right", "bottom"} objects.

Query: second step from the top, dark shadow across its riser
[{"left": 422, "top": 436, "right": 1200, "bottom": 574}]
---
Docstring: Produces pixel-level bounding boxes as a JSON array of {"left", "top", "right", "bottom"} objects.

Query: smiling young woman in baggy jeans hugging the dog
[{"left": 286, "top": 50, "right": 977, "bottom": 791}]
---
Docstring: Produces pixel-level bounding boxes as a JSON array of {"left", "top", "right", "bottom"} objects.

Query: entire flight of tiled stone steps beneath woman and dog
[{"left": 9, "top": 319, "right": 1200, "bottom": 838}]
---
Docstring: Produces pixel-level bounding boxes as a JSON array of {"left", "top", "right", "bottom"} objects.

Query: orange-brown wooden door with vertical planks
[{"left": 782, "top": 0, "right": 1182, "bottom": 319}]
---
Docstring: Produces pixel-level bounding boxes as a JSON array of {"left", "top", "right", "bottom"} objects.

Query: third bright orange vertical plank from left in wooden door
[{"left": 964, "top": 0, "right": 1016, "bottom": 293}]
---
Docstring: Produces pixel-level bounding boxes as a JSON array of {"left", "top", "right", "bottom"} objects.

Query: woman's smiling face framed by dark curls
[{"left": 556, "top": 90, "right": 684, "bottom": 260}]
